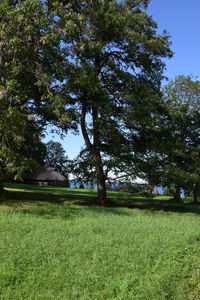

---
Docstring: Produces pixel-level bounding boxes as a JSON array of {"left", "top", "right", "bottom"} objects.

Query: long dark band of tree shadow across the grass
[{"left": 1, "top": 191, "right": 200, "bottom": 218}]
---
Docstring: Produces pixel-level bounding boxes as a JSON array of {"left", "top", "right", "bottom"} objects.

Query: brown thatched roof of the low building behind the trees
[{"left": 24, "top": 165, "right": 66, "bottom": 181}]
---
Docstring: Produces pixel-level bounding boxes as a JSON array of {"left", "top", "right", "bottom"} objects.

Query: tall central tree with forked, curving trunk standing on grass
[{"left": 48, "top": 0, "right": 172, "bottom": 204}]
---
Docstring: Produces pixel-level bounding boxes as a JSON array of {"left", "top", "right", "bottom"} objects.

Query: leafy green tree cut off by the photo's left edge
[{"left": 0, "top": 0, "right": 60, "bottom": 192}]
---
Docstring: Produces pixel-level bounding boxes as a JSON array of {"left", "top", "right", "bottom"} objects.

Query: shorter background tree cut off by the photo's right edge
[{"left": 139, "top": 75, "right": 200, "bottom": 201}]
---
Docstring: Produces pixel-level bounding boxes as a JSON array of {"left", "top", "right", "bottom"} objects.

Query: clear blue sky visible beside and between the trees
[{"left": 44, "top": 0, "right": 200, "bottom": 159}]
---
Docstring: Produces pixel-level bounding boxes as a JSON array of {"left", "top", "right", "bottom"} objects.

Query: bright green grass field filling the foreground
[{"left": 0, "top": 186, "right": 200, "bottom": 300}]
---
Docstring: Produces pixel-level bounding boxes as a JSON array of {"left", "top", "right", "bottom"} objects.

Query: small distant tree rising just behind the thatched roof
[{"left": 44, "top": 141, "right": 69, "bottom": 184}]
